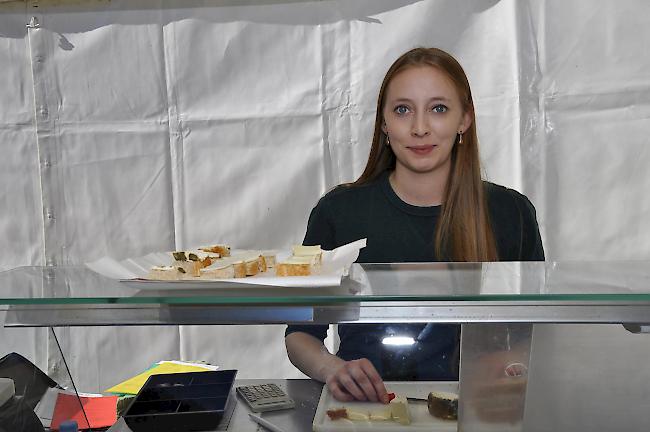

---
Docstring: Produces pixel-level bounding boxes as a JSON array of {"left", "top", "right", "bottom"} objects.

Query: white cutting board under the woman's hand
[{"left": 313, "top": 381, "right": 458, "bottom": 432}]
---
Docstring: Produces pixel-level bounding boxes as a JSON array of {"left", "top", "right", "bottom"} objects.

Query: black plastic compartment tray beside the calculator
[{"left": 124, "top": 370, "right": 237, "bottom": 432}]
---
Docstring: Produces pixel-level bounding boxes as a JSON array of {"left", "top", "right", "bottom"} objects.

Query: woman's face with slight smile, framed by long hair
[{"left": 382, "top": 66, "right": 472, "bottom": 179}]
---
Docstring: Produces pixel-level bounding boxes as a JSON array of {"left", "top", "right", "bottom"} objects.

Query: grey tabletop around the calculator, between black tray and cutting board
[{"left": 108, "top": 379, "right": 323, "bottom": 432}]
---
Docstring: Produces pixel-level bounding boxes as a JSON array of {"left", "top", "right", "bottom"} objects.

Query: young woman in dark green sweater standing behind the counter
[{"left": 285, "top": 48, "right": 544, "bottom": 403}]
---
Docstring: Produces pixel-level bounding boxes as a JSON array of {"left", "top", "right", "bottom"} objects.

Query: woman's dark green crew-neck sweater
[{"left": 287, "top": 172, "right": 544, "bottom": 380}]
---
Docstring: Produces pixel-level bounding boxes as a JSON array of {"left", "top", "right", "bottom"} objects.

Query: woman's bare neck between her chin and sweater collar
[{"left": 388, "top": 167, "right": 447, "bottom": 207}]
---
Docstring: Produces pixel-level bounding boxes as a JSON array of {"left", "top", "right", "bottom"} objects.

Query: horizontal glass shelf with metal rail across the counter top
[{"left": 0, "top": 261, "right": 650, "bottom": 326}]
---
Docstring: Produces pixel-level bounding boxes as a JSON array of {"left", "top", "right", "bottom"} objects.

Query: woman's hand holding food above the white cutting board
[{"left": 325, "top": 358, "right": 389, "bottom": 403}]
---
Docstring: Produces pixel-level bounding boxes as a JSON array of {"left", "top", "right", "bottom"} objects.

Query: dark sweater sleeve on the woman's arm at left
[{"left": 284, "top": 198, "right": 336, "bottom": 341}]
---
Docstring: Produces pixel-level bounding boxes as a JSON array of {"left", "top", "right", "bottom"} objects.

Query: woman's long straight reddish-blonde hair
[{"left": 351, "top": 48, "right": 499, "bottom": 262}]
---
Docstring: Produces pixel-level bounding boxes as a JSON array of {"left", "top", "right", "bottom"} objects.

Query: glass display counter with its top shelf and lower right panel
[{"left": 0, "top": 261, "right": 650, "bottom": 431}]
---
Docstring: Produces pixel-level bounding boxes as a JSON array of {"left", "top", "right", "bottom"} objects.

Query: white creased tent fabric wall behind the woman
[{"left": 0, "top": 0, "right": 650, "bottom": 391}]
